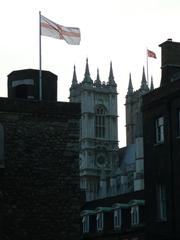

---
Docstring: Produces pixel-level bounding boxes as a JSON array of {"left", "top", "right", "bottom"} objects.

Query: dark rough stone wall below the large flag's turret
[{"left": 0, "top": 98, "right": 82, "bottom": 240}]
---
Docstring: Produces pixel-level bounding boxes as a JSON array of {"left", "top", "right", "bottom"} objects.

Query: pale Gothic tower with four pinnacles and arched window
[{"left": 70, "top": 59, "right": 118, "bottom": 201}]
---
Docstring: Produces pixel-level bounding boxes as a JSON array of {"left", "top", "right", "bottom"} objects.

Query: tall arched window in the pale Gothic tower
[{"left": 95, "top": 106, "right": 106, "bottom": 138}]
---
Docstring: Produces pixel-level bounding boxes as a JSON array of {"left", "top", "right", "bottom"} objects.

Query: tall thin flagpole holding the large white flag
[{"left": 39, "top": 11, "right": 42, "bottom": 101}]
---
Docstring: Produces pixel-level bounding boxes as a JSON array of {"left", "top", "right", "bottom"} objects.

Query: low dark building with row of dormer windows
[{"left": 81, "top": 191, "right": 145, "bottom": 240}]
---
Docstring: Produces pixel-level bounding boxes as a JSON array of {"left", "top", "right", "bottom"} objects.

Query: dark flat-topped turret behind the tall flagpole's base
[{"left": 8, "top": 69, "right": 57, "bottom": 101}]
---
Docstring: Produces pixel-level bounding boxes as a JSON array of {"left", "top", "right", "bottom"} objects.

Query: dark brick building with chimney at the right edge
[{"left": 143, "top": 39, "right": 180, "bottom": 240}]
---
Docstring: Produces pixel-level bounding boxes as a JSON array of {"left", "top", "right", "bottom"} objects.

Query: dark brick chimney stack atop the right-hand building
[{"left": 159, "top": 38, "right": 180, "bottom": 86}]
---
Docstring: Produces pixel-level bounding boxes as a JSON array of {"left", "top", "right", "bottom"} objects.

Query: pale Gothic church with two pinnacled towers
[{"left": 70, "top": 60, "right": 152, "bottom": 201}]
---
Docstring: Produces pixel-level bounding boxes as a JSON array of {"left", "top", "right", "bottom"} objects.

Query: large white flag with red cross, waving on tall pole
[{"left": 41, "top": 15, "right": 81, "bottom": 45}]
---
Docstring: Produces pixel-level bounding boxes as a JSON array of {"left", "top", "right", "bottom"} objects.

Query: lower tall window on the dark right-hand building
[{"left": 157, "top": 184, "right": 167, "bottom": 221}]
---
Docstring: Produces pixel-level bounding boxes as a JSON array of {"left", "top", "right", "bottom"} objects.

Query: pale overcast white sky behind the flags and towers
[{"left": 0, "top": 0, "right": 180, "bottom": 147}]
